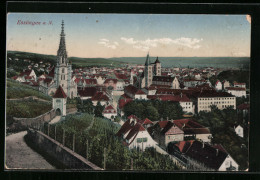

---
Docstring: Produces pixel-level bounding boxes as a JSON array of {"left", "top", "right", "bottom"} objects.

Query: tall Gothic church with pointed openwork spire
[{"left": 39, "top": 21, "right": 77, "bottom": 98}]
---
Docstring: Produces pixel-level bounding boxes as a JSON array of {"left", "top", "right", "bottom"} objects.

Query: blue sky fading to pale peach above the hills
[{"left": 6, "top": 13, "right": 251, "bottom": 58}]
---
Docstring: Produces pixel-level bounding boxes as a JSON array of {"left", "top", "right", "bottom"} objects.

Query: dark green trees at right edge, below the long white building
[{"left": 196, "top": 106, "right": 248, "bottom": 170}]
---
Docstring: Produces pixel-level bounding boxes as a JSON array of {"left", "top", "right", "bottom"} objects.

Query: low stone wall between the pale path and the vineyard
[{"left": 27, "top": 129, "right": 102, "bottom": 170}]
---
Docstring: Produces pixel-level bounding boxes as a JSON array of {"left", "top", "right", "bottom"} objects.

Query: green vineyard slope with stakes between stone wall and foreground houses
[{"left": 44, "top": 113, "right": 177, "bottom": 171}]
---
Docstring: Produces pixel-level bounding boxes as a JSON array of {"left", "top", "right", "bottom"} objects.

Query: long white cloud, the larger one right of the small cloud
[{"left": 121, "top": 37, "right": 203, "bottom": 51}]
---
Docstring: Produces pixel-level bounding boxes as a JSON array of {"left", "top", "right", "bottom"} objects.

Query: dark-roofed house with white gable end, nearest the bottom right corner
[{"left": 168, "top": 140, "right": 239, "bottom": 171}]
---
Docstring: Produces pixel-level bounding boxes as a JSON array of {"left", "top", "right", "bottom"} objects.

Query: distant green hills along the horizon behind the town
[{"left": 7, "top": 51, "right": 250, "bottom": 69}]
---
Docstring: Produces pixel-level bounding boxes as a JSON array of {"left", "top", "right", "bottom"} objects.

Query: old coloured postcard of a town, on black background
[{"left": 5, "top": 13, "right": 251, "bottom": 172}]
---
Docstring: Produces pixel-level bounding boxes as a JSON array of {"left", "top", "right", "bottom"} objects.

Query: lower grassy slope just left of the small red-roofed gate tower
[{"left": 6, "top": 100, "right": 52, "bottom": 118}]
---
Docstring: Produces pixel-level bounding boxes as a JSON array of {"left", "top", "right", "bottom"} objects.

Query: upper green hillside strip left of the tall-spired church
[{"left": 6, "top": 79, "right": 52, "bottom": 100}]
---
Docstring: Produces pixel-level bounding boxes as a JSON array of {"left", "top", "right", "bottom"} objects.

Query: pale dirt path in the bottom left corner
[{"left": 5, "top": 131, "right": 55, "bottom": 169}]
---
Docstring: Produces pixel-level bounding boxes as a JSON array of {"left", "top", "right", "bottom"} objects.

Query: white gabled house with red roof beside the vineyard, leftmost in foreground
[{"left": 116, "top": 118, "right": 157, "bottom": 151}]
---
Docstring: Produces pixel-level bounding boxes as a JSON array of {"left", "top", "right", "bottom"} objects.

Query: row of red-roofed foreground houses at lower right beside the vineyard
[{"left": 116, "top": 115, "right": 239, "bottom": 171}]
